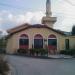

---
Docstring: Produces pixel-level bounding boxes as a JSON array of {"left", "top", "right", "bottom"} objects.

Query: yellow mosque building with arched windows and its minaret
[{"left": 6, "top": 0, "right": 75, "bottom": 54}]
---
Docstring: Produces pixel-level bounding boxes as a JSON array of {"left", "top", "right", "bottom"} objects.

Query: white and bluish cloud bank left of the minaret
[{"left": 0, "top": 10, "right": 44, "bottom": 31}]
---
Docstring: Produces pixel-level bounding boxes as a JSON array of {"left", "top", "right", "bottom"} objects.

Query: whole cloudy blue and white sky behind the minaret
[{"left": 0, "top": 0, "right": 75, "bottom": 32}]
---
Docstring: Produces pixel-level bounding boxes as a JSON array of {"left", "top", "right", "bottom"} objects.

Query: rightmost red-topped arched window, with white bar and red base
[{"left": 48, "top": 34, "right": 57, "bottom": 54}]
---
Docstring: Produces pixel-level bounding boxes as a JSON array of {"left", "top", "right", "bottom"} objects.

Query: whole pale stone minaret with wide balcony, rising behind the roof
[{"left": 42, "top": 0, "right": 56, "bottom": 28}]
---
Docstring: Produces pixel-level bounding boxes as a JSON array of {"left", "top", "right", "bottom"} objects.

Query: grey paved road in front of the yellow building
[{"left": 7, "top": 55, "right": 75, "bottom": 75}]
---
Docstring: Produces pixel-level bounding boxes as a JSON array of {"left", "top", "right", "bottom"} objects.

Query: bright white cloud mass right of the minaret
[{"left": 53, "top": 0, "right": 75, "bottom": 31}]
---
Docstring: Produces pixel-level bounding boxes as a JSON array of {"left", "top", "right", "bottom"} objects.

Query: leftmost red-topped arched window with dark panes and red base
[{"left": 19, "top": 34, "right": 29, "bottom": 49}]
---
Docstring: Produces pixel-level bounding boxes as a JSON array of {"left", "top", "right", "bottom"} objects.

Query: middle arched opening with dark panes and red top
[{"left": 34, "top": 34, "right": 43, "bottom": 48}]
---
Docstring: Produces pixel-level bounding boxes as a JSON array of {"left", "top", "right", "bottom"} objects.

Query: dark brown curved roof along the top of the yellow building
[{"left": 7, "top": 24, "right": 65, "bottom": 35}]
